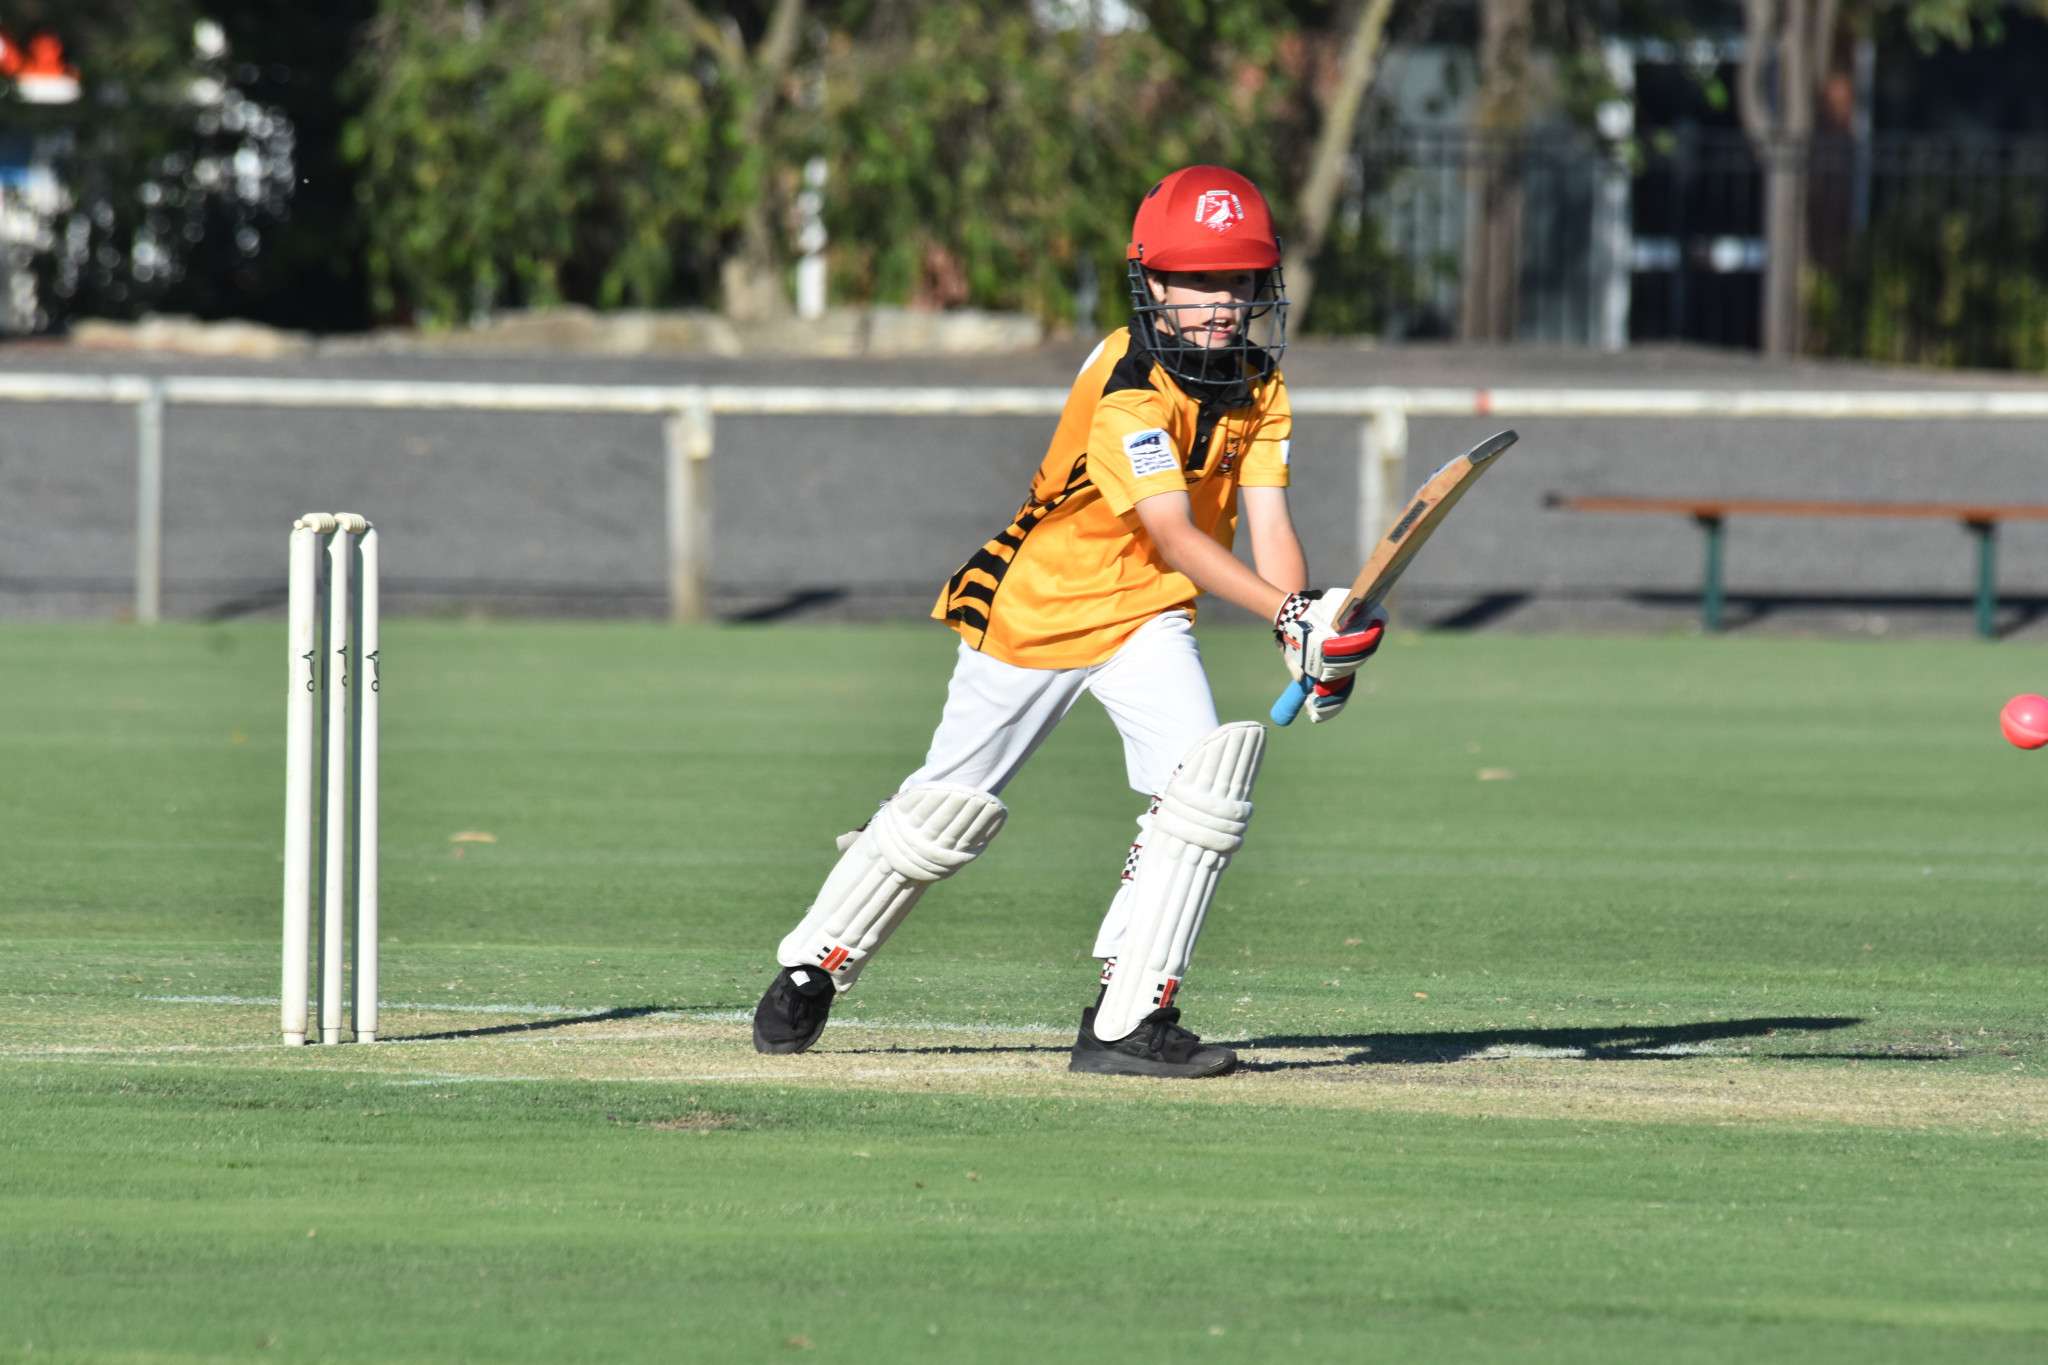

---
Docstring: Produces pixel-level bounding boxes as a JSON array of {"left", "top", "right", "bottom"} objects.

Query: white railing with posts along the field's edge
[{"left": 0, "top": 372, "right": 2048, "bottom": 622}]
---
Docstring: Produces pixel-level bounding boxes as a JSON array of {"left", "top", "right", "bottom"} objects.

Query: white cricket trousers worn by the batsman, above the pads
[{"left": 899, "top": 612, "right": 1217, "bottom": 958}]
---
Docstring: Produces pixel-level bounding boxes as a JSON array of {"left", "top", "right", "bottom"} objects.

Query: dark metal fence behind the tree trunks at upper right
[{"left": 1323, "top": 127, "right": 2048, "bottom": 370}]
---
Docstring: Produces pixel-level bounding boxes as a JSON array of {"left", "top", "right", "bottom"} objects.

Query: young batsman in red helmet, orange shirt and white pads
[{"left": 754, "top": 166, "right": 1386, "bottom": 1076}]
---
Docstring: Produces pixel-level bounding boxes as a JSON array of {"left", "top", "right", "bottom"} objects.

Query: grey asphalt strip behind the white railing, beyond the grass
[{"left": 0, "top": 342, "right": 2048, "bottom": 636}]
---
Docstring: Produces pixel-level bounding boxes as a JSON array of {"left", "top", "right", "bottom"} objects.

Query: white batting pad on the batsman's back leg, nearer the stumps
[{"left": 776, "top": 782, "right": 1010, "bottom": 990}]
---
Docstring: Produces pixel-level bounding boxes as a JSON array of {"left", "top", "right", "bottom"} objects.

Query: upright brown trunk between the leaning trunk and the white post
[{"left": 1458, "top": 0, "right": 1536, "bottom": 342}]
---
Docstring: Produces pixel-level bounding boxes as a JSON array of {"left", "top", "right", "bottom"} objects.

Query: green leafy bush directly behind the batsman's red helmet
[{"left": 821, "top": 2, "right": 1284, "bottom": 319}]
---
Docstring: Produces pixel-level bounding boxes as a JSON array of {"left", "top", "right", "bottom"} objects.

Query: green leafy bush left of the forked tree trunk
[{"left": 346, "top": 0, "right": 731, "bottom": 325}]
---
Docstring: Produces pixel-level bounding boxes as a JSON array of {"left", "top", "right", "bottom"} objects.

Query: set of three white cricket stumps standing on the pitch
[{"left": 283, "top": 512, "right": 379, "bottom": 1046}]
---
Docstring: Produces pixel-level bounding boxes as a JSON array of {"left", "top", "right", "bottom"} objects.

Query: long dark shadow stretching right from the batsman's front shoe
[{"left": 1233, "top": 1015, "right": 1875, "bottom": 1070}]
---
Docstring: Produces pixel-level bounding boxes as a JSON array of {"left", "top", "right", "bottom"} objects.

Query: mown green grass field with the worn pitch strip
[{"left": 0, "top": 622, "right": 2048, "bottom": 1365}]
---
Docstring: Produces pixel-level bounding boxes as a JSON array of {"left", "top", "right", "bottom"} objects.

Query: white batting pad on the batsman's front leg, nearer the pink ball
[{"left": 1096, "top": 720, "right": 1266, "bottom": 1042}]
